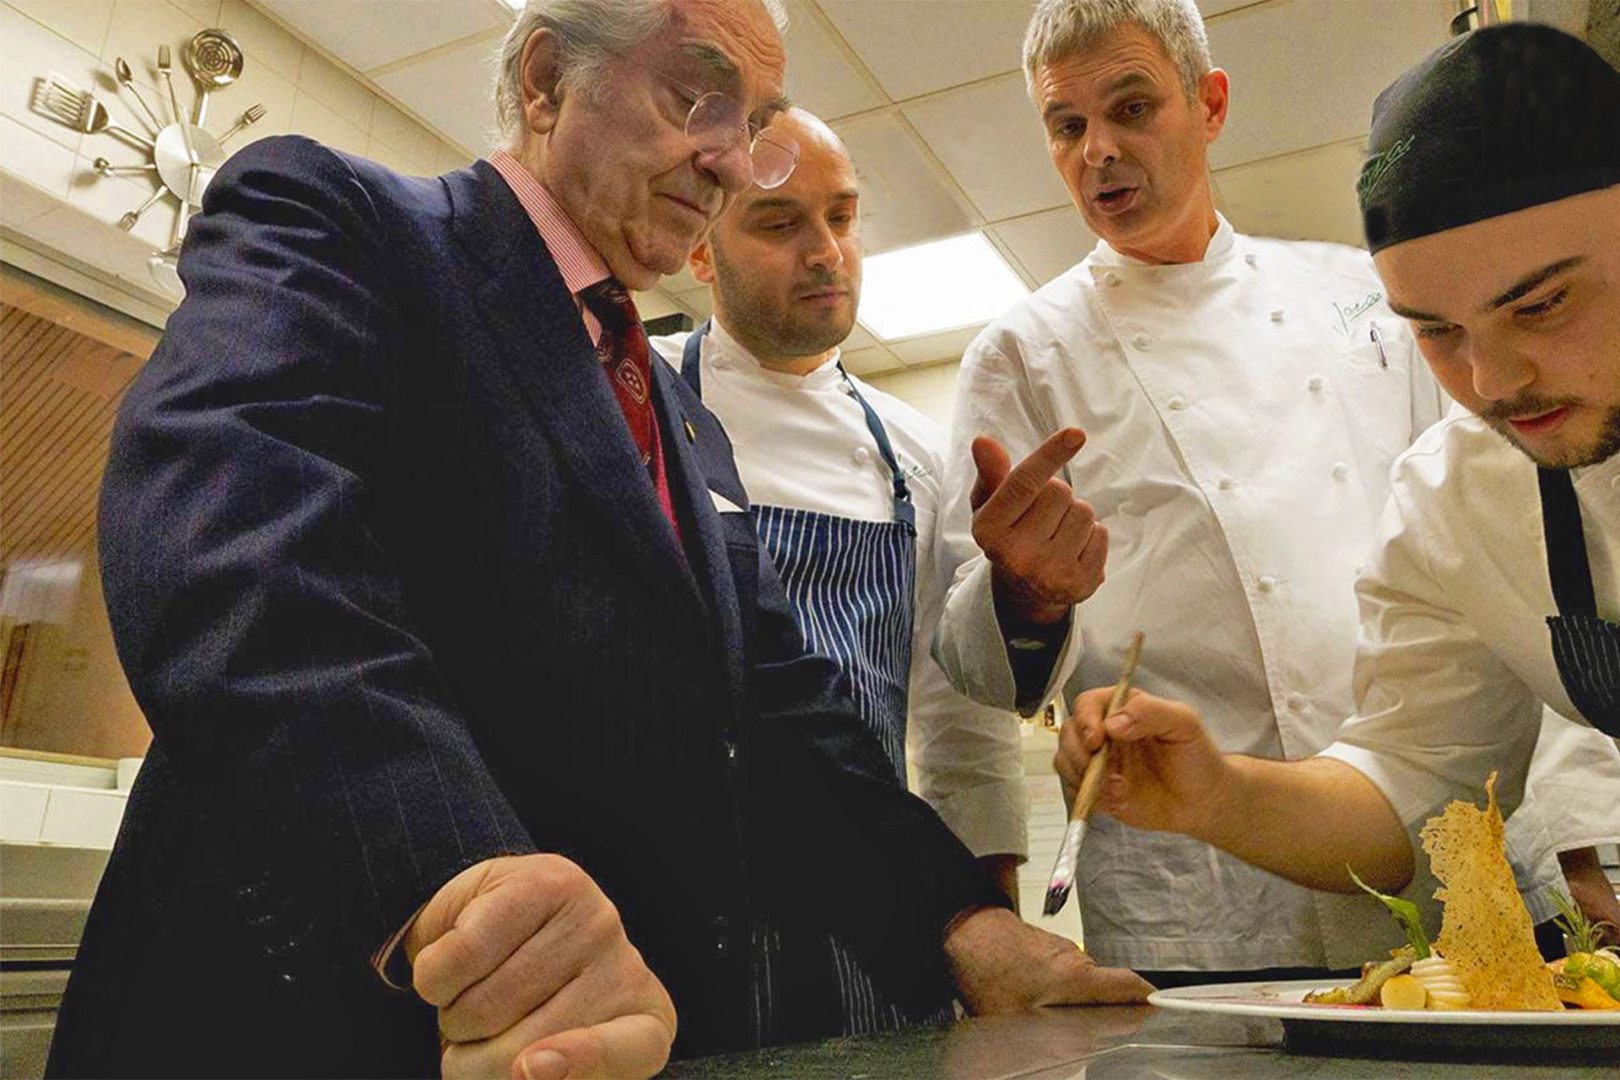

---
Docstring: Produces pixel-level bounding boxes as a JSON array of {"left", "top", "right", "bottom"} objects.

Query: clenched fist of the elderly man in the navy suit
[{"left": 405, "top": 855, "right": 676, "bottom": 1080}]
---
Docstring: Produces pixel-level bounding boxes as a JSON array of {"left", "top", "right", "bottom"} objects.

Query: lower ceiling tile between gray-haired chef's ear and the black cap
[{"left": 1215, "top": 139, "right": 1362, "bottom": 246}]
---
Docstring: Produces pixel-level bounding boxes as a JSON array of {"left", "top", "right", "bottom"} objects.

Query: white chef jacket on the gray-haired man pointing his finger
[{"left": 936, "top": 219, "right": 1607, "bottom": 970}]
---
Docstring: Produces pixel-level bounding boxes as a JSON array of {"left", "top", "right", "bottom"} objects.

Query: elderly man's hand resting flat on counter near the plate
[{"left": 944, "top": 908, "right": 1153, "bottom": 1015}]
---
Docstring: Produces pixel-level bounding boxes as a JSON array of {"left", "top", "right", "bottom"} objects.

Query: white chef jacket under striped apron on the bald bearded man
[{"left": 651, "top": 319, "right": 1029, "bottom": 858}]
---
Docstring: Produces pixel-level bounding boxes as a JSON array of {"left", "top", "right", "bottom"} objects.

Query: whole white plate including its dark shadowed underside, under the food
[{"left": 1147, "top": 980, "right": 1620, "bottom": 1062}]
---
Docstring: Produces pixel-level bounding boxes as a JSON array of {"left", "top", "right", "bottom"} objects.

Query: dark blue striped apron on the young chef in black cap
[{"left": 1536, "top": 468, "right": 1620, "bottom": 738}]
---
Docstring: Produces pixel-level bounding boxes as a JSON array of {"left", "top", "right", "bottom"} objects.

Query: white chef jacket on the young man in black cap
[{"left": 1324, "top": 410, "right": 1620, "bottom": 863}]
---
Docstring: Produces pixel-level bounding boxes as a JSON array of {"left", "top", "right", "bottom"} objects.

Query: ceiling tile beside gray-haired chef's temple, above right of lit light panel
[{"left": 901, "top": 74, "right": 1069, "bottom": 222}]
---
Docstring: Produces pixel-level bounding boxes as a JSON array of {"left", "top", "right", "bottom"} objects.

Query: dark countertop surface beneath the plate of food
[{"left": 664, "top": 1006, "right": 1620, "bottom": 1080}]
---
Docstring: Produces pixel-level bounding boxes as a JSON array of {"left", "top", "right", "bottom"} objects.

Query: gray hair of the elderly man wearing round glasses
[{"left": 496, "top": 0, "right": 787, "bottom": 141}]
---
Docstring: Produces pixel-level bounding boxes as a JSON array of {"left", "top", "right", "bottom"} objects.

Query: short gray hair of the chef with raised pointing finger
[{"left": 1024, "top": 0, "right": 1215, "bottom": 97}]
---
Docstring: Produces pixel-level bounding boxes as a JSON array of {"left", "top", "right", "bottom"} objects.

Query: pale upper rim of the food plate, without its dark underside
[{"left": 1147, "top": 980, "right": 1620, "bottom": 1028}]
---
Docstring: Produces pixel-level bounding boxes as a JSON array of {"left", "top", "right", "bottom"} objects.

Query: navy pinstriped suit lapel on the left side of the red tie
[{"left": 444, "top": 162, "right": 703, "bottom": 607}]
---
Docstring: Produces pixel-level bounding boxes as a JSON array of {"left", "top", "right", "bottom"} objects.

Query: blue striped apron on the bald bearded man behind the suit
[{"left": 680, "top": 322, "right": 949, "bottom": 1035}]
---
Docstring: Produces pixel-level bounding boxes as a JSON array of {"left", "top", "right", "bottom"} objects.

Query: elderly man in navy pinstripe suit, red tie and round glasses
[{"left": 50, "top": 0, "right": 1145, "bottom": 1077}]
